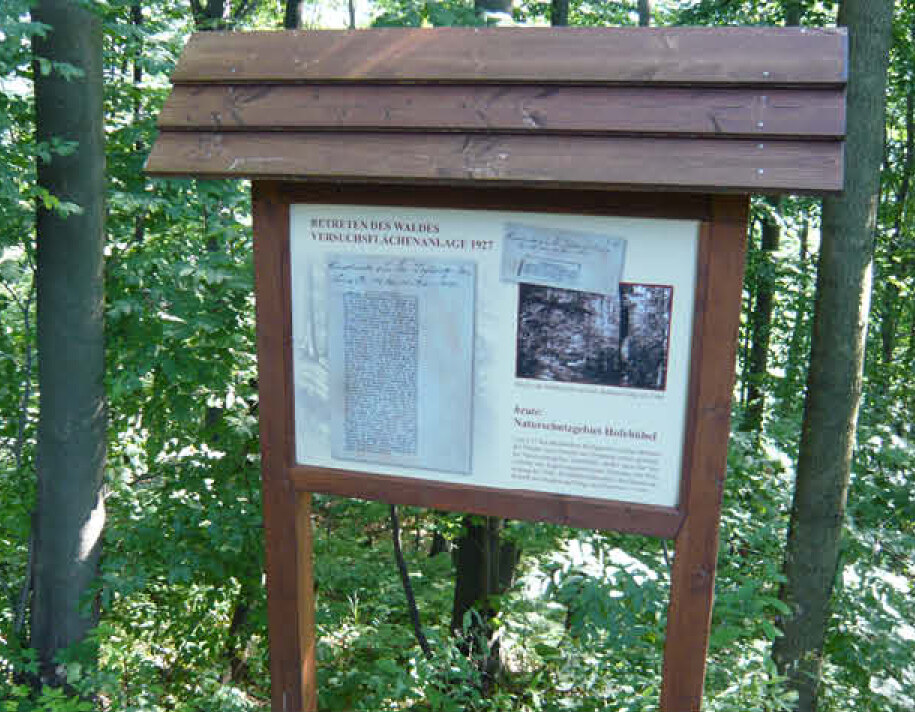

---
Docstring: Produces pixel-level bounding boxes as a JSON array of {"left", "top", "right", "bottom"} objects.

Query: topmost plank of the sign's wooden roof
[{"left": 172, "top": 27, "right": 847, "bottom": 86}]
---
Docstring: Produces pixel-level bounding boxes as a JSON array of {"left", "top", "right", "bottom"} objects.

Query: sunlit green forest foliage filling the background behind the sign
[{"left": 0, "top": 0, "right": 915, "bottom": 712}]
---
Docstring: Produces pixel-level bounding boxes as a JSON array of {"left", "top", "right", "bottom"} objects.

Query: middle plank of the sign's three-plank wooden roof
[{"left": 159, "top": 84, "right": 845, "bottom": 140}]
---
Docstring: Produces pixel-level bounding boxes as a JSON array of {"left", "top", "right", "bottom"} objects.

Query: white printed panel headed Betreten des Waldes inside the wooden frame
[{"left": 290, "top": 204, "right": 698, "bottom": 506}]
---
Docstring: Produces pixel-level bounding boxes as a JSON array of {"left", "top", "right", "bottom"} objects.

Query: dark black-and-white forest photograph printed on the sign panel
[{"left": 515, "top": 283, "right": 673, "bottom": 391}]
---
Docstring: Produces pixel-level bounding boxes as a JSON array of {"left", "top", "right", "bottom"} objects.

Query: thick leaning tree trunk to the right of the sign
[{"left": 773, "top": 0, "right": 893, "bottom": 712}]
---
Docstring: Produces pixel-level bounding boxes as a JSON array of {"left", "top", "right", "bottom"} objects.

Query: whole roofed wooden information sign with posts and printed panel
[{"left": 148, "top": 28, "right": 846, "bottom": 712}]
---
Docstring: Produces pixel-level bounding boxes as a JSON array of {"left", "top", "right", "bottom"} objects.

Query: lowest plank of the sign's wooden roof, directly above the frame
[{"left": 146, "top": 132, "right": 843, "bottom": 193}]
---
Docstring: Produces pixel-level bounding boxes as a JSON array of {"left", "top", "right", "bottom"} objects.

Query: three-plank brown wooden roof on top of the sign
[{"left": 147, "top": 27, "right": 847, "bottom": 192}]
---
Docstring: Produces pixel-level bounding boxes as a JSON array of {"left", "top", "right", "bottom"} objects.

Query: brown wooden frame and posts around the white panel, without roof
[{"left": 253, "top": 181, "right": 747, "bottom": 712}]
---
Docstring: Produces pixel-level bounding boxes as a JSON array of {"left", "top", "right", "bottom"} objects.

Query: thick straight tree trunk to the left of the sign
[{"left": 31, "top": 0, "right": 107, "bottom": 683}]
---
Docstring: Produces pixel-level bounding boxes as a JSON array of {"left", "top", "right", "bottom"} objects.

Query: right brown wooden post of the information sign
[{"left": 661, "top": 196, "right": 748, "bottom": 712}]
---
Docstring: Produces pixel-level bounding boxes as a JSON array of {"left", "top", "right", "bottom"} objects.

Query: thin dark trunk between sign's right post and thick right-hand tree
[{"left": 740, "top": 216, "right": 781, "bottom": 433}]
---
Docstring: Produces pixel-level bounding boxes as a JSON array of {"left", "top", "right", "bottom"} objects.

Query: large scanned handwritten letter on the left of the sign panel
[{"left": 327, "top": 255, "right": 475, "bottom": 473}]
